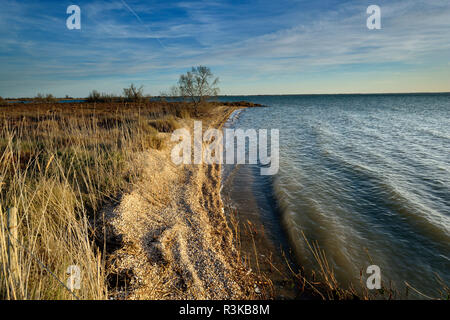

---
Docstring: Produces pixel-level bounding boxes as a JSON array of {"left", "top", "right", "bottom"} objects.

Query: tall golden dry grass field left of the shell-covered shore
[{"left": 0, "top": 103, "right": 189, "bottom": 299}]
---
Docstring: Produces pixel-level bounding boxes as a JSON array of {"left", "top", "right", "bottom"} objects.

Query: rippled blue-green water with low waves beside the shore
[{"left": 223, "top": 94, "right": 450, "bottom": 296}]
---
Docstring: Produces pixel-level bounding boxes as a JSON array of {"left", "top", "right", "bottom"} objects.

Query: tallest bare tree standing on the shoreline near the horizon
[{"left": 177, "top": 66, "right": 219, "bottom": 114}]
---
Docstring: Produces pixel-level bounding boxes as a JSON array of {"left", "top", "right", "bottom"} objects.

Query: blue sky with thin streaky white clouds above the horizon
[{"left": 0, "top": 0, "right": 450, "bottom": 98}]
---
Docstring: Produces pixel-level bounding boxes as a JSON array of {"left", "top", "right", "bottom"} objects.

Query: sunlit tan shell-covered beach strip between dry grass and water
[{"left": 106, "top": 107, "right": 261, "bottom": 299}]
